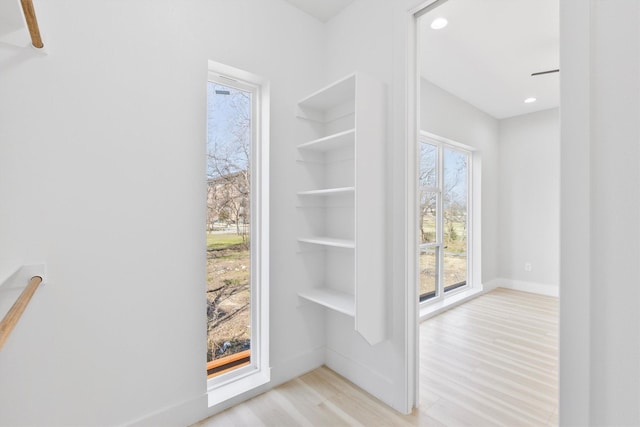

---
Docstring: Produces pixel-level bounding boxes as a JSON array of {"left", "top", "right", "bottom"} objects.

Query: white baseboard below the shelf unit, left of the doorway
[{"left": 324, "top": 348, "right": 397, "bottom": 407}]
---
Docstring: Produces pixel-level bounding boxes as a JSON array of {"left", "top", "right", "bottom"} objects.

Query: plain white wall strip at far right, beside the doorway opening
[{"left": 560, "top": 0, "right": 640, "bottom": 426}]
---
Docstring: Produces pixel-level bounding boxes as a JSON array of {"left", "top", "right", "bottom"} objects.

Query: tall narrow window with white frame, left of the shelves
[{"left": 205, "top": 61, "right": 268, "bottom": 404}]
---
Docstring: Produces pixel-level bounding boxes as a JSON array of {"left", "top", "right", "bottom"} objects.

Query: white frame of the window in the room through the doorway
[{"left": 415, "top": 130, "right": 475, "bottom": 307}]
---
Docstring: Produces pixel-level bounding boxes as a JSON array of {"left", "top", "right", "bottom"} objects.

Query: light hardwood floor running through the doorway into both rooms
[{"left": 196, "top": 288, "right": 558, "bottom": 427}]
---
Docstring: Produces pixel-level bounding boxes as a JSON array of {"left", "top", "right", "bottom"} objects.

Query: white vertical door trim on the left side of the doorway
[{"left": 389, "top": 0, "right": 448, "bottom": 414}]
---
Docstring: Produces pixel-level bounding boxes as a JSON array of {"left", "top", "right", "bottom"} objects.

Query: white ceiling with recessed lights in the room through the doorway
[{"left": 419, "top": 0, "right": 560, "bottom": 119}]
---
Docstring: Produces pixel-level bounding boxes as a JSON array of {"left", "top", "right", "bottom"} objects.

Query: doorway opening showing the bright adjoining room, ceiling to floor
[{"left": 412, "top": 0, "right": 560, "bottom": 424}]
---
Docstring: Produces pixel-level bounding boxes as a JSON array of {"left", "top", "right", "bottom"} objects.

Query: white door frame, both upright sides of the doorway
[{"left": 391, "top": 0, "right": 594, "bottom": 425}]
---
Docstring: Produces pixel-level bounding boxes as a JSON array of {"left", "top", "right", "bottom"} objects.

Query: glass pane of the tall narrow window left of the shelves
[{"left": 207, "top": 81, "right": 252, "bottom": 376}]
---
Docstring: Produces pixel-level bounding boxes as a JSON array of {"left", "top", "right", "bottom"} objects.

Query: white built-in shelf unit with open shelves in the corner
[{"left": 296, "top": 73, "right": 386, "bottom": 344}]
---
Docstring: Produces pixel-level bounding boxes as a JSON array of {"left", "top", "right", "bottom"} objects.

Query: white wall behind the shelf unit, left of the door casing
[{"left": 326, "top": 0, "right": 410, "bottom": 412}]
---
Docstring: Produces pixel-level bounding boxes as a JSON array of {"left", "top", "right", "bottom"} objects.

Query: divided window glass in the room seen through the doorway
[{"left": 418, "top": 138, "right": 471, "bottom": 302}]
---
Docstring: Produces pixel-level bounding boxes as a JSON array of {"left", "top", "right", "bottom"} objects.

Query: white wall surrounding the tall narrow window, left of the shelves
[{"left": 0, "top": 0, "right": 325, "bottom": 426}]
